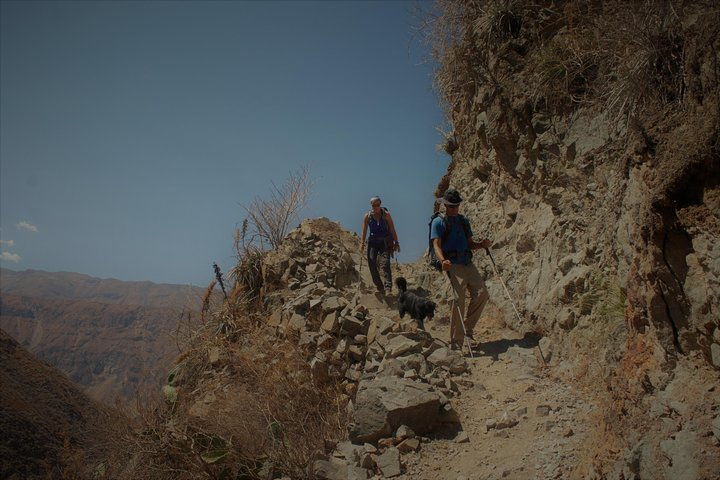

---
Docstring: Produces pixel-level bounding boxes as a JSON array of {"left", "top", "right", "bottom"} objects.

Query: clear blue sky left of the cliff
[{"left": 0, "top": 0, "right": 449, "bottom": 286}]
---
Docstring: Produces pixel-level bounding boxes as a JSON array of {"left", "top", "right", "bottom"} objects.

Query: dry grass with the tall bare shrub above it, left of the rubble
[{"left": 108, "top": 170, "right": 347, "bottom": 480}]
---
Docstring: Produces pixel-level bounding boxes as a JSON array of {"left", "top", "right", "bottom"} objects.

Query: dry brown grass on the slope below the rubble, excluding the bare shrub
[{"left": 121, "top": 286, "right": 347, "bottom": 479}]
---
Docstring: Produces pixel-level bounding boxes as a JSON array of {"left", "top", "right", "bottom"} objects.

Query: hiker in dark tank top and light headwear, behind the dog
[{"left": 360, "top": 197, "right": 400, "bottom": 295}]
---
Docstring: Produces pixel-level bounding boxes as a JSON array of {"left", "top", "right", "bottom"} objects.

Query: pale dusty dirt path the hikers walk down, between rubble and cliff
[{"left": 363, "top": 266, "right": 596, "bottom": 480}]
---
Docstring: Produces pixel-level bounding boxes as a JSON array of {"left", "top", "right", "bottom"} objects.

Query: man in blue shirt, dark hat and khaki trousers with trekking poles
[{"left": 430, "top": 188, "right": 492, "bottom": 350}]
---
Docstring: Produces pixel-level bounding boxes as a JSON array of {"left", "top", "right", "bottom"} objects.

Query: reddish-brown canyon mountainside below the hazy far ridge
[{"left": 0, "top": 294, "right": 180, "bottom": 404}]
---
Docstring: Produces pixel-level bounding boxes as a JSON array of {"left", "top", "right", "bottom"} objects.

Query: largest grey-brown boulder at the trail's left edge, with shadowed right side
[{"left": 350, "top": 377, "right": 446, "bottom": 443}]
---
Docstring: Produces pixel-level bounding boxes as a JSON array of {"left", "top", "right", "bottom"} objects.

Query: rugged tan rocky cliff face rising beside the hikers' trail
[{"left": 436, "top": 2, "right": 720, "bottom": 478}]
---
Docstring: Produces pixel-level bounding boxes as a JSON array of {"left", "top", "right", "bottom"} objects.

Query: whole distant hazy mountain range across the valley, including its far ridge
[{"left": 0, "top": 268, "right": 212, "bottom": 403}]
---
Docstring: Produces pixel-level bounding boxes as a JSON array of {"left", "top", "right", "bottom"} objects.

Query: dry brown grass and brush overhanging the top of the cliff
[{"left": 425, "top": 0, "right": 718, "bottom": 122}]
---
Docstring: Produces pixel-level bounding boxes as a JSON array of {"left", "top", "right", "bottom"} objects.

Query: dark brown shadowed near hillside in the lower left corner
[{"left": 0, "top": 330, "right": 119, "bottom": 478}]
